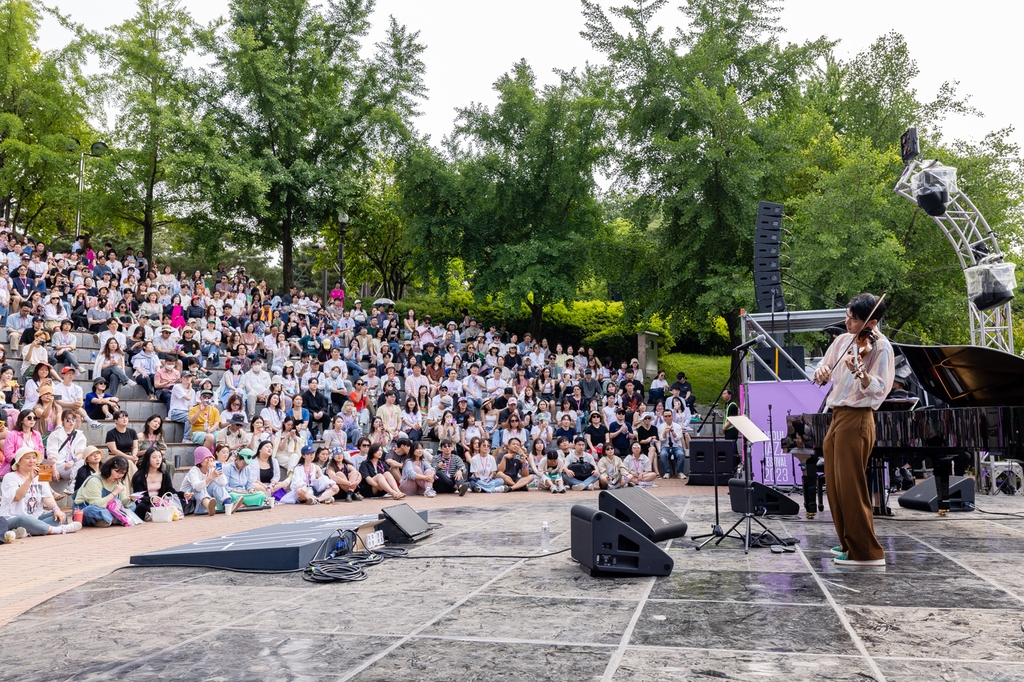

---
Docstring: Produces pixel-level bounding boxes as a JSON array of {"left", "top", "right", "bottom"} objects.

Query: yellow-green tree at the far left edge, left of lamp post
[{"left": 0, "top": 0, "right": 91, "bottom": 237}]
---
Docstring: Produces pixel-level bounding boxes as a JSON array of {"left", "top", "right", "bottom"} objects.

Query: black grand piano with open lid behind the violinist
[{"left": 804, "top": 344, "right": 1024, "bottom": 513}]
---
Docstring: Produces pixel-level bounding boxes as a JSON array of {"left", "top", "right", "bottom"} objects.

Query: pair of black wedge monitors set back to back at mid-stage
[{"left": 569, "top": 487, "right": 686, "bottom": 578}]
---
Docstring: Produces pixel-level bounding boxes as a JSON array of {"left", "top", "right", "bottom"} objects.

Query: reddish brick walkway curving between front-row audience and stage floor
[{"left": 0, "top": 480, "right": 712, "bottom": 627}]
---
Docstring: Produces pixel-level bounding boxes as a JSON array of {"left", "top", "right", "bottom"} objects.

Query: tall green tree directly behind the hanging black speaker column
[{"left": 584, "top": 0, "right": 827, "bottom": 348}]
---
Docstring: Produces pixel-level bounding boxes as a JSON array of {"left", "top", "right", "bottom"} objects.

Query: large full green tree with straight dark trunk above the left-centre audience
[{"left": 213, "top": 0, "right": 424, "bottom": 286}]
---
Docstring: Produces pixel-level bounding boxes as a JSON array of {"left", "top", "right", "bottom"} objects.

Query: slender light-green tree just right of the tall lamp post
[{"left": 93, "top": 0, "right": 217, "bottom": 259}]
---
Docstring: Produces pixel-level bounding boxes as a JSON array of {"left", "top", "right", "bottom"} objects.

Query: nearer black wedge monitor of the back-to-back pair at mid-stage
[{"left": 569, "top": 505, "right": 675, "bottom": 578}]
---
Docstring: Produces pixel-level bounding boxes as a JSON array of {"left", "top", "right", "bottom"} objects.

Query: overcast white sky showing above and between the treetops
[{"left": 42, "top": 0, "right": 1024, "bottom": 149}]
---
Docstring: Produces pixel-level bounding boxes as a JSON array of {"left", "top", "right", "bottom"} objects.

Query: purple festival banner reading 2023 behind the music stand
[{"left": 745, "top": 381, "right": 828, "bottom": 485}]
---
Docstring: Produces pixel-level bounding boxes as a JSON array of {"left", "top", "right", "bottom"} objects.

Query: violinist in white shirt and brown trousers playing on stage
[{"left": 814, "top": 294, "right": 895, "bottom": 567}]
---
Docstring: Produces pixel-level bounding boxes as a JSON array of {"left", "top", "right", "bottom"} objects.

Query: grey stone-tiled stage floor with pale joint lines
[{"left": 0, "top": 495, "right": 1024, "bottom": 682}]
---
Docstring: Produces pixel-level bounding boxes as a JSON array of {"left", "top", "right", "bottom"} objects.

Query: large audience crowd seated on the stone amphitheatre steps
[{"left": 0, "top": 231, "right": 694, "bottom": 537}]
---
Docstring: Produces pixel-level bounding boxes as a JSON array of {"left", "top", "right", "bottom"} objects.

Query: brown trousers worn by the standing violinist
[{"left": 821, "top": 408, "right": 885, "bottom": 561}]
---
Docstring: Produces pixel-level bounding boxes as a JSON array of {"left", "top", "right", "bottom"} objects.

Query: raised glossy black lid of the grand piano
[{"left": 893, "top": 344, "right": 1024, "bottom": 408}]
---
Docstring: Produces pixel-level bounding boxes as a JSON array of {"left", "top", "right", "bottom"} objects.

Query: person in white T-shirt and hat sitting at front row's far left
[{"left": 0, "top": 446, "right": 82, "bottom": 538}]
